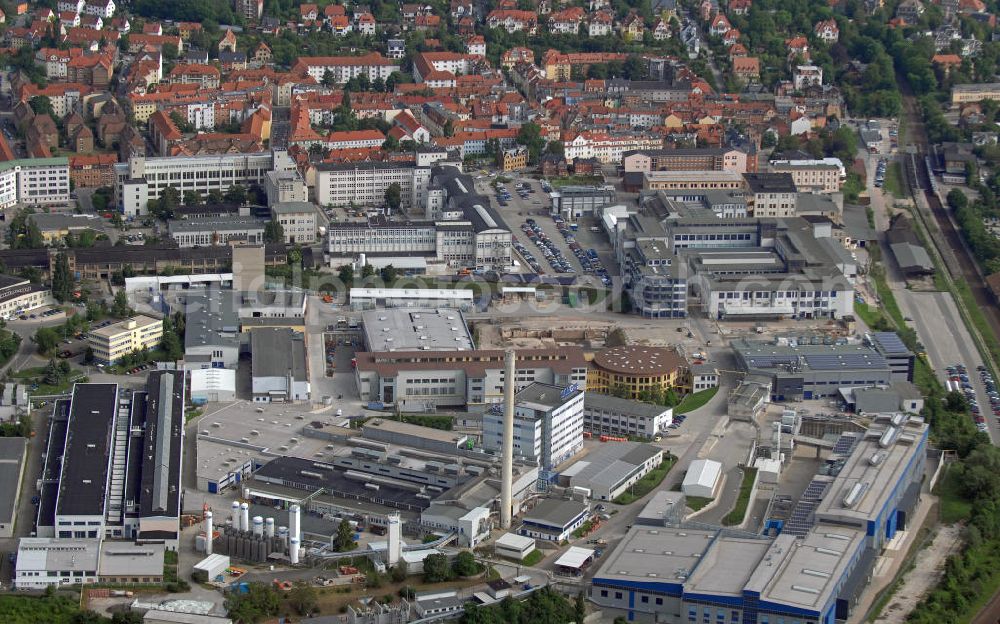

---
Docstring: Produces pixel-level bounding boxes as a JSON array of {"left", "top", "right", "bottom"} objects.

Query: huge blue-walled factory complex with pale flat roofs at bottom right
[{"left": 589, "top": 415, "right": 928, "bottom": 624}]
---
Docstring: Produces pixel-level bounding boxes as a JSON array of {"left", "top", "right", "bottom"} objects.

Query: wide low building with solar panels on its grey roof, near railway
[{"left": 733, "top": 334, "right": 912, "bottom": 401}]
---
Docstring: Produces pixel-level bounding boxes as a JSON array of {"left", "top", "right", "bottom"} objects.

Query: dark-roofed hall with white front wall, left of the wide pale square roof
[{"left": 250, "top": 327, "right": 310, "bottom": 403}]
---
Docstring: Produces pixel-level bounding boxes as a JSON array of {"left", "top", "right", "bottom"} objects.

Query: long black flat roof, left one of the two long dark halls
[{"left": 56, "top": 383, "right": 118, "bottom": 516}]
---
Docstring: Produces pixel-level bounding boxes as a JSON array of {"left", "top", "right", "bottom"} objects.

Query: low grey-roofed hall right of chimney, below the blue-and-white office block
[{"left": 559, "top": 442, "right": 663, "bottom": 501}]
